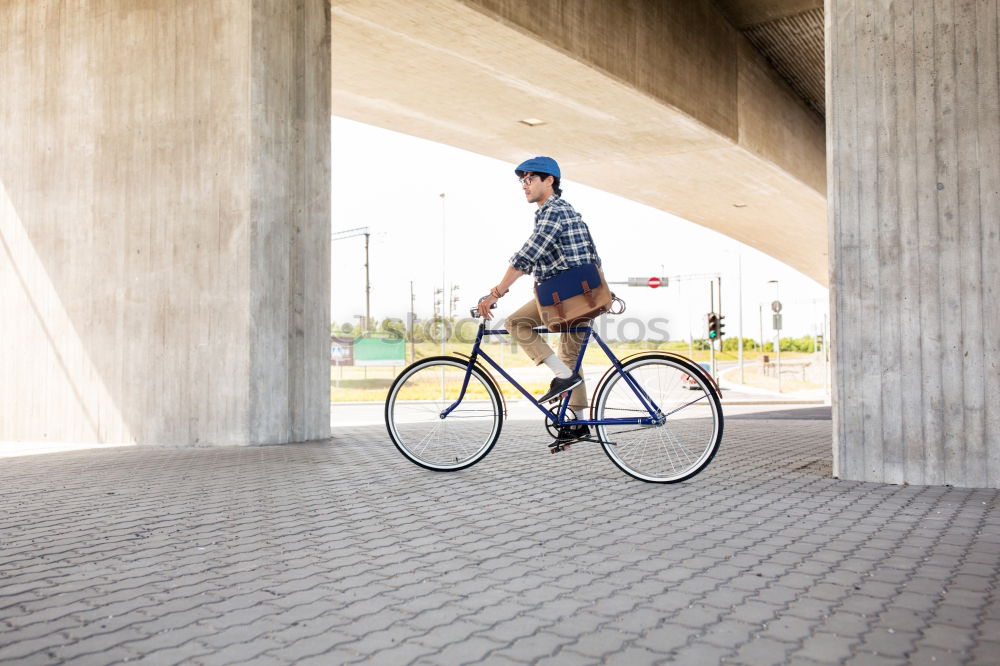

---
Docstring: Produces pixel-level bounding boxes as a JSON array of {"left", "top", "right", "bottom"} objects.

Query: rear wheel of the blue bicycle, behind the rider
[{"left": 594, "top": 355, "right": 722, "bottom": 483}]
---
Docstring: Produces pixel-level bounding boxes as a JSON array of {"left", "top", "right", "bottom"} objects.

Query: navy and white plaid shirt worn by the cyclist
[{"left": 510, "top": 194, "right": 601, "bottom": 282}]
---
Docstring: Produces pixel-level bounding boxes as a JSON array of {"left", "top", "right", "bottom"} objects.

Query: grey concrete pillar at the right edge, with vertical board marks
[{"left": 826, "top": 0, "right": 1000, "bottom": 488}]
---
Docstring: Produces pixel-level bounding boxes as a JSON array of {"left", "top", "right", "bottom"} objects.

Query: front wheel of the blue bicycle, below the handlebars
[{"left": 385, "top": 356, "right": 503, "bottom": 472}]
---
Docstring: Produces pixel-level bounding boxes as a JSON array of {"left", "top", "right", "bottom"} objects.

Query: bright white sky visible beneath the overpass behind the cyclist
[{"left": 331, "top": 116, "right": 829, "bottom": 340}]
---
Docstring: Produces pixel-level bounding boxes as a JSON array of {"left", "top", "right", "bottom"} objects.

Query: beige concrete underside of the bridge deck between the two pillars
[{"left": 331, "top": 0, "right": 829, "bottom": 286}]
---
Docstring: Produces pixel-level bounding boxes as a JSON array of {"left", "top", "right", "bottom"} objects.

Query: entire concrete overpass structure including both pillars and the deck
[{"left": 0, "top": 0, "right": 1000, "bottom": 487}]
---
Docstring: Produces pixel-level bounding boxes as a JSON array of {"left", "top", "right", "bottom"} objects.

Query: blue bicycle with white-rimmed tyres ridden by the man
[{"left": 385, "top": 309, "right": 723, "bottom": 483}]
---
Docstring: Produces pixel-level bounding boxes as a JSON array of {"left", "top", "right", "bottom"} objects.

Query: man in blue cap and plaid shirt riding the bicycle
[{"left": 479, "top": 157, "right": 601, "bottom": 445}]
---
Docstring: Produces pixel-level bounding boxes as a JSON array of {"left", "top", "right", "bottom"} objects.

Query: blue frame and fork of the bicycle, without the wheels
[{"left": 441, "top": 324, "right": 666, "bottom": 426}]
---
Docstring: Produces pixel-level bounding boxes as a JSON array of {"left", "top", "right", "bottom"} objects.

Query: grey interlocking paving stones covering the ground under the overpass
[{"left": 0, "top": 418, "right": 1000, "bottom": 666}]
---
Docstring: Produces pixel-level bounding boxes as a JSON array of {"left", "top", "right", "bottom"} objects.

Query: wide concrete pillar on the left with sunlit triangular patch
[{"left": 0, "top": 0, "right": 330, "bottom": 445}]
